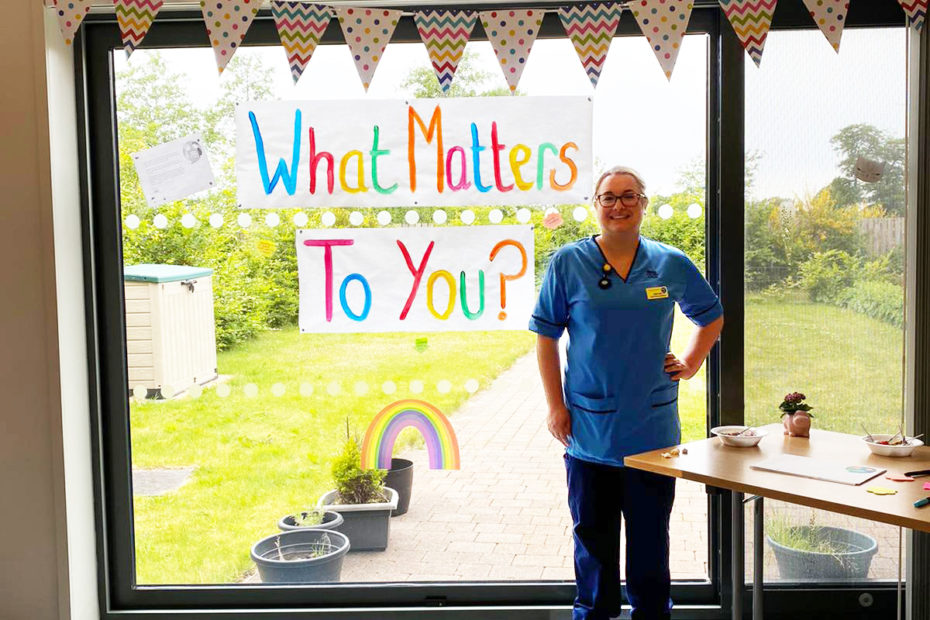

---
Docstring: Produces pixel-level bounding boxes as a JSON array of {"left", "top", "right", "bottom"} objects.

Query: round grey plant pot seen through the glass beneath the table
[{"left": 765, "top": 525, "right": 878, "bottom": 581}]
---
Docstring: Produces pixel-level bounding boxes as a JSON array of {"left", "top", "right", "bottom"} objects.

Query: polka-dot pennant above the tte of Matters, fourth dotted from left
[{"left": 478, "top": 9, "right": 545, "bottom": 93}]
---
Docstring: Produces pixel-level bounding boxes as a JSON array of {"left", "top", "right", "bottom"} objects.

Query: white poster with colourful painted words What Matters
[{"left": 236, "top": 97, "right": 592, "bottom": 209}]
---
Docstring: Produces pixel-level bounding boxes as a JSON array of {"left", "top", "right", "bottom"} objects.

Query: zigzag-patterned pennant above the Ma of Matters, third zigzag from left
[{"left": 413, "top": 11, "right": 478, "bottom": 92}]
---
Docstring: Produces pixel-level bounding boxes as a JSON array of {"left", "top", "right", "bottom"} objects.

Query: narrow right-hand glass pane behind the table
[{"left": 745, "top": 28, "right": 906, "bottom": 582}]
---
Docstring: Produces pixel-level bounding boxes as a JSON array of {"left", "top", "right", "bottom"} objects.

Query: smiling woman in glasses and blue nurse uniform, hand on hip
[{"left": 530, "top": 167, "right": 723, "bottom": 620}]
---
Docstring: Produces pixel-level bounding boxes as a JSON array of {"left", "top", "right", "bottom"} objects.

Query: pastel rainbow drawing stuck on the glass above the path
[{"left": 361, "top": 399, "right": 461, "bottom": 469}]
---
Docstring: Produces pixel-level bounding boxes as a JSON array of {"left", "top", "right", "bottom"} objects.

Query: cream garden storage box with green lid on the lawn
[{"left": 123, "top": 265, "right": 217, "bottom": 398}]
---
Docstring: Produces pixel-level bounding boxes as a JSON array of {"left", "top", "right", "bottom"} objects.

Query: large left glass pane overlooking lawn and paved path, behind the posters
[{"left": 114, "top": 36, "right": 707, "bottom": 584}]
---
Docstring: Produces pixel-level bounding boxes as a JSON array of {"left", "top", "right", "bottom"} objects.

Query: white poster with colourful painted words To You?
[{"left": 296, "top": 226, "right": 536, "bottom": 333}]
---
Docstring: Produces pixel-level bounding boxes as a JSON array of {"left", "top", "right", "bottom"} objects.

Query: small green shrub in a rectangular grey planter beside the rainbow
[{"left": 317, "top": 428, "right": 397, "bottom": 551}]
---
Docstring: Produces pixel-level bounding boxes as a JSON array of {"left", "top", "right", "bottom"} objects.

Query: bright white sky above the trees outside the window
[{"left": 115, "top": 28, "right": 907, "bottom": 198}]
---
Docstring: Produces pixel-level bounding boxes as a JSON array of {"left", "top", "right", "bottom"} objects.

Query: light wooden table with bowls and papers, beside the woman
[{"left": 623, "top": 424, "right": 930, "bottom": 620}]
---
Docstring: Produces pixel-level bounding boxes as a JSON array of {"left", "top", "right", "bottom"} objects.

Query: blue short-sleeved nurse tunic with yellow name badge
[{"left": 529, "top": 237, "right": 723, "bottom": 467}]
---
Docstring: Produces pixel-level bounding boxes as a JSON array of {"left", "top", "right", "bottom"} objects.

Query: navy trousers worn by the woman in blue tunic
[{"left": 565, "top": 454, "right": 675, "bottom": 620}]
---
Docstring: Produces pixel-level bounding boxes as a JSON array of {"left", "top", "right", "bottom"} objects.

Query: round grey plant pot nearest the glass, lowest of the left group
[{"left": 251, "top": 528, "right": 350, "bottom": 583}]
